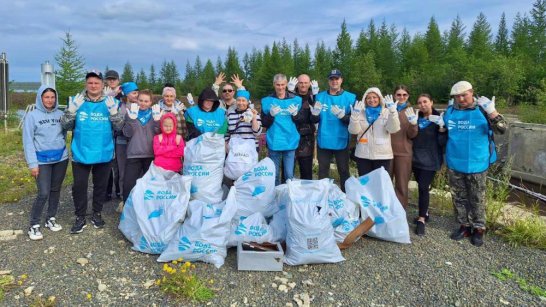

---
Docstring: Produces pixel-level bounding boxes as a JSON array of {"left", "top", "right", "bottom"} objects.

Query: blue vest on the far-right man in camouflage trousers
[{"left": 444, "top": 106, "right": 497, "bottom": 174}]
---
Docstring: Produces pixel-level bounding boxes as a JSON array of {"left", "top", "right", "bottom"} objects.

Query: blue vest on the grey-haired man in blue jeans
[{"left": 262, "top": 96, "right": 301, "bottom": 151}]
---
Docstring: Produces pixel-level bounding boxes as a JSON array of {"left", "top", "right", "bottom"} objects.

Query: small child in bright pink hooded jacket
[{"left": 154, "top": 112, "right": 186, "bottom": 173}]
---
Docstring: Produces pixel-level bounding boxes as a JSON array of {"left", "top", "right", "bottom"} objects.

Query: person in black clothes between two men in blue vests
[{"left": 288, "top": 74, "right": 319, "bottom": 179}]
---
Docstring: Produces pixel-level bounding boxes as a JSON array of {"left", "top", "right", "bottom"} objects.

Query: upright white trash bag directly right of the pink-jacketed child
[{"left": 183, "top": 132, "right": 225, "bottom": 204}]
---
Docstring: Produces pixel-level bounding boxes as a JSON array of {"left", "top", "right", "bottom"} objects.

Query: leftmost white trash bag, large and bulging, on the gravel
[{"left": 118, "top": 163, "right": 191, "bottom": 254}]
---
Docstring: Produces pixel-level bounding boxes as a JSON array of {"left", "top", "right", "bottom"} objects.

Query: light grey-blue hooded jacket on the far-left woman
[{"left": 23, "top": 85, "right": 68, "bottom": 168}]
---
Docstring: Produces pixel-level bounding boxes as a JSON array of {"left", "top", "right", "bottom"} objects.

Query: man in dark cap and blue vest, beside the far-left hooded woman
[{"left": 61, "top": 70, "right": 123, "bottom": 234}]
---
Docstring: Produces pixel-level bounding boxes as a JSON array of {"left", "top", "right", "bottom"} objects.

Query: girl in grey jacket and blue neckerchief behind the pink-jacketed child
[{"left": 123, "top": 90, "right": 161, "bottom": 202}]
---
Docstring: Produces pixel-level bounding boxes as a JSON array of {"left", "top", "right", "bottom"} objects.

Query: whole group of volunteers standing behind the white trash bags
[{"left": 23, "top": 69, "right": 507, "bottom": 246}]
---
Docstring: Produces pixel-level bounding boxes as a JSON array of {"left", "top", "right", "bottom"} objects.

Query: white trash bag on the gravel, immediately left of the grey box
[{"left": 157, "top": 187, "right": 237, "bottom": 268}]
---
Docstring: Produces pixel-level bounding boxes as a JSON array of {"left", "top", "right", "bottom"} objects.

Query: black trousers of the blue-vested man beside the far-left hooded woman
[{"left": 72, "top": 161, "right": 111, "bottom": 217}]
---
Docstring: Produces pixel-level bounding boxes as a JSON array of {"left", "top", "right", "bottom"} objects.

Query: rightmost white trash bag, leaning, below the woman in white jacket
[{"left": 345, "top": 167, "right": 411, "bottom": 243}]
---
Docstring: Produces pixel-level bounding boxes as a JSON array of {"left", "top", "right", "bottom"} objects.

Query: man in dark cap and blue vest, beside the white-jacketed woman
[{"left": 311, "top": 69, "right": 356, "bottom": 191}]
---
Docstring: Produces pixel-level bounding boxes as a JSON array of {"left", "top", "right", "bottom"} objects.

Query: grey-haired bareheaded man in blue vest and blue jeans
[{"left": 260, "top": 74, "right": 301, "bottom": 185}]
